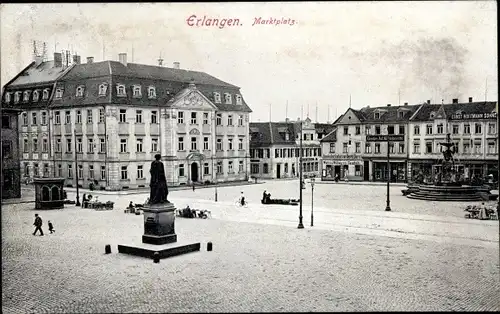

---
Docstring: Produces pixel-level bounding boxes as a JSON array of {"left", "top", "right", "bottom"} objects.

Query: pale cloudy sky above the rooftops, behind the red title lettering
[{"left": 0, "top": 1, "right": 498, "bottom": 123}]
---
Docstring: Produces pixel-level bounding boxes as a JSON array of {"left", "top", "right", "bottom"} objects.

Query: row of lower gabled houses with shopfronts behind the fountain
[{"left": 250, "top": 98, "right": 498, "bottom": 182}]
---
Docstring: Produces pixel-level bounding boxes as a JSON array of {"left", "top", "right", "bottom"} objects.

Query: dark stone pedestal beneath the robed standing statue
[{"left": 142, "top": 203, "right": 177, "bottom": 245}]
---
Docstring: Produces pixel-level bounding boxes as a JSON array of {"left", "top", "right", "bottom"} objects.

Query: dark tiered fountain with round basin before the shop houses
[{"left": 402, "top": 133, "right": 498, "bottom": 201}]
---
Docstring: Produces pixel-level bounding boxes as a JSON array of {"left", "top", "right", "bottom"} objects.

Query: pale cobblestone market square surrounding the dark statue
[{"left": 2, "top": 180, "right": 500, "bottom": 313}]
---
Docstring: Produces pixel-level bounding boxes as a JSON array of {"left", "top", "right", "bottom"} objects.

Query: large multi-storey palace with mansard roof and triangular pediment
[{"left": 2, "top": 53, "right": 251, "bottom": 190}]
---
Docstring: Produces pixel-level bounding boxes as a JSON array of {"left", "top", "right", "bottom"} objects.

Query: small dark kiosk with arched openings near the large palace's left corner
[{"left": 33, "top": 178, "right": 65, "bottom": 209}]
